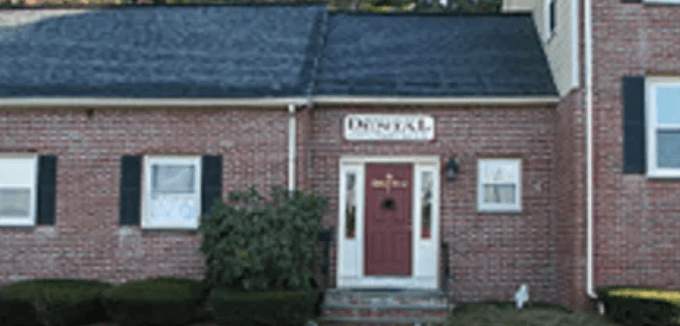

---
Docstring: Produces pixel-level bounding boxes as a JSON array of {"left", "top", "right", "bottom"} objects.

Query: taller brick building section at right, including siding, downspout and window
[{"left": 504, "top": 0, "right": 680, "bottom": 305}]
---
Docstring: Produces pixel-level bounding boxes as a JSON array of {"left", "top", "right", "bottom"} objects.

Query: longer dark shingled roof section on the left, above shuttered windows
[{"left": 0, "top": 5, "right": 325, "bottom": 98}]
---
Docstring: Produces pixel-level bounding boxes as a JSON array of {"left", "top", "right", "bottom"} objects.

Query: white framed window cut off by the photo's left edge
[{"left": 0, "top": 154, "right": 38, "bottom": 226}]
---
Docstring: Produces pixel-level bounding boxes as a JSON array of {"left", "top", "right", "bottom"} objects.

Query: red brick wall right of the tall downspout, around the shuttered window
[{"left": 593, "top": 0, "right": 680, "bottom": 289}]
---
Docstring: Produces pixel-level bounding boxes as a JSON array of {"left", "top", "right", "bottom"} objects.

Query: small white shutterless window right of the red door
[{"left": 477, "top": 159, "right": 522, "bottom": 212}]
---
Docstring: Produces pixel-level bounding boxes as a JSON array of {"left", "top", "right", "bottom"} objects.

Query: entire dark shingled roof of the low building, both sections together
[{"left": 0, "top": 5, "right": 557, "bottom": 98}]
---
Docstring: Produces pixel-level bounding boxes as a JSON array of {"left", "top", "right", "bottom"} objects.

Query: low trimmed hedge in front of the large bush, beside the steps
[{"left": 209, "top": 288, "right": 319, "bottom": 326}]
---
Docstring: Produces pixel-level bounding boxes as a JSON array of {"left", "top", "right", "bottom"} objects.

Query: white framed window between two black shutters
[{"left": 142, "top": 155, "right": 201, "bottom": 229}]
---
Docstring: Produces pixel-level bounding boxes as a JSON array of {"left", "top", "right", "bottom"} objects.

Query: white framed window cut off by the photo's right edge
[{"left": 645, "top": 77, "right": 680, "bottom": 178}]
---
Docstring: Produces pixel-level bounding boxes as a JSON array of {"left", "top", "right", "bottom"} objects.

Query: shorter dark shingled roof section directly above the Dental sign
[{"left": 315, "top": 13, "right": 557, "bottom": 96}]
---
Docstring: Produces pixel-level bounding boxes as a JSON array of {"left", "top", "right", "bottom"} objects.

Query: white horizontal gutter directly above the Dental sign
[{"left": 312, "top": 95, "right": 560, "bottom": 105}]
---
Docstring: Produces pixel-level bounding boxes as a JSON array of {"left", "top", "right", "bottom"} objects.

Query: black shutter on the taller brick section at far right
[{"left": 622, "top": 76, "right": 647, "bottom": 173}]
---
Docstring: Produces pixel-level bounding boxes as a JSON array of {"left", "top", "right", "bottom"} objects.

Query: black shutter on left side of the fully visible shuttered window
[{"left": 120, "top": 156, "right": 142, "bottom": 225}]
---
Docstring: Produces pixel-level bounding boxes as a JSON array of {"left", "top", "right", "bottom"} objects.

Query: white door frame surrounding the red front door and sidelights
[{"left": 336, "top": 155, "right": 440, "bottom": 289}]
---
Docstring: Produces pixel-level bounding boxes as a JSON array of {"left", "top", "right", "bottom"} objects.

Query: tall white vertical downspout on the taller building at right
[{"left": 583, "top": 0, "right": 597, "bottom": 299}]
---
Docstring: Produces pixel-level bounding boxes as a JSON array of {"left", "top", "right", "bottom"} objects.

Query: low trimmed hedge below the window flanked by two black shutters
[{"left": 104, "top": 277, "right": 207, "bottom": 326}]
